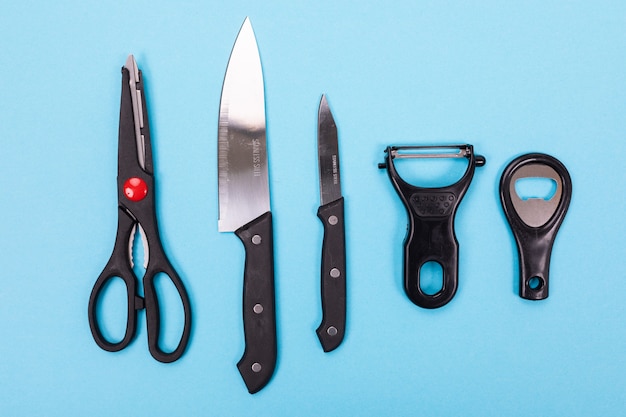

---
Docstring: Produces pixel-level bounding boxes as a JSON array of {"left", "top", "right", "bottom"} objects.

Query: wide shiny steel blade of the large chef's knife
[{"left": 217, "top": 18, "right": 270, "bottom": 232}]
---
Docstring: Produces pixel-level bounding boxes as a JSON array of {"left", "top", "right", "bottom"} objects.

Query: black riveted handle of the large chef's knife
[{"left": 235, "top": 211, "right": 277, "bottom": 394}]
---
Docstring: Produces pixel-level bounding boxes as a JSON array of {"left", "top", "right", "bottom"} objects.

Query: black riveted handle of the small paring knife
[{"left": 316, "top": 197, "right": 346, "bottom": 352}]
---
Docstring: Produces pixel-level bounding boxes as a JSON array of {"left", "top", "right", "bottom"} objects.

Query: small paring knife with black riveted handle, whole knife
[{"left": 317, "top": 96, "right": 346, "bottom": 352}]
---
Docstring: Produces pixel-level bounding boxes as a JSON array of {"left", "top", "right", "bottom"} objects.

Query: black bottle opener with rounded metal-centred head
[{"left": 500, "top": 153, "right": 572, "bottom": 300}]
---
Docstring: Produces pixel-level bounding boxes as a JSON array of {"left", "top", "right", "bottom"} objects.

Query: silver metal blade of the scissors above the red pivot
[{"left": 122, "top": 55, "right": 152, "bottom": 172}]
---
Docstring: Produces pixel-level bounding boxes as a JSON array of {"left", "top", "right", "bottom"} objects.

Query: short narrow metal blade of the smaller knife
[{"left": 317, "top": 95, "right": 341, "bottom": 205}]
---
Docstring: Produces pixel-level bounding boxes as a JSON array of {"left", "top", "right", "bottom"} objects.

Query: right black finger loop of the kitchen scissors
[{"left": 143, "top": 255, "right": 191, "bottom": 363}]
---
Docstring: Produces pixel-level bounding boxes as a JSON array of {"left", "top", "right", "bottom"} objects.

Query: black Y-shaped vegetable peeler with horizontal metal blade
[{"left": 378, "top": 145, "right": 485, "bottom": 308}]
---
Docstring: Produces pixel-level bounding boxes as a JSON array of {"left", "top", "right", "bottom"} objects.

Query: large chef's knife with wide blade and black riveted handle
[{"left": 217, "top": 18, "right": 277, "bottom": 394}]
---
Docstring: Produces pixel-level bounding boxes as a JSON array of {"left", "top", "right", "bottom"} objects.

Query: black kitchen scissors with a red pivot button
[{"left": 88, "top": 55, "right": 191, "bottom": 363}]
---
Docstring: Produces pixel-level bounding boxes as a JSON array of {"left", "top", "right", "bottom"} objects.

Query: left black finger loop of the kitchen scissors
[{"left": 88, "top": 264, "right": 143, "bottom": 352}]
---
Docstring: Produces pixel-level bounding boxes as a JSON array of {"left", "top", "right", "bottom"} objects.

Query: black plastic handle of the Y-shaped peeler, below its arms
[{"left": 404, "top": 192, "right": 459, "bottom": 309}]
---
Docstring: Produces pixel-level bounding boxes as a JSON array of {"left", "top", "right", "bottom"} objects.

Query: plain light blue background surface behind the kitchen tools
[{"left": 0, "top": 0, "right": 626, "bottom": 417}]
